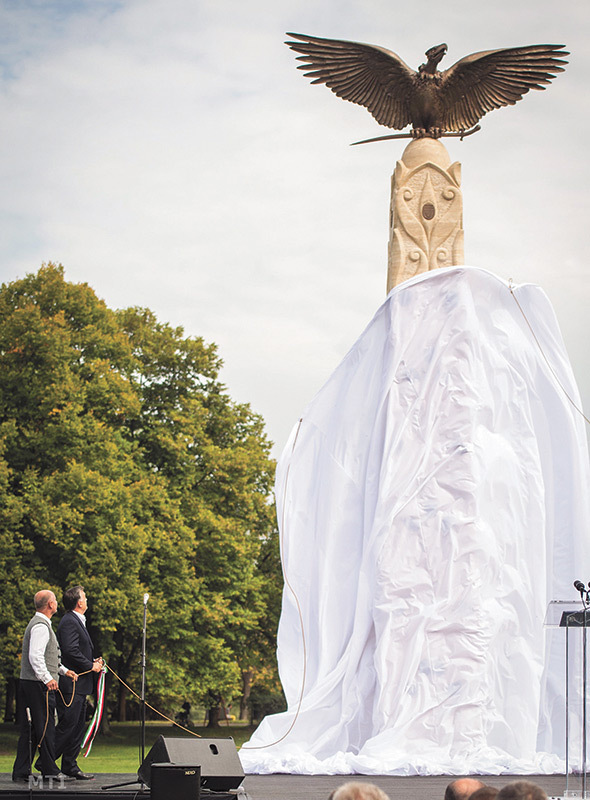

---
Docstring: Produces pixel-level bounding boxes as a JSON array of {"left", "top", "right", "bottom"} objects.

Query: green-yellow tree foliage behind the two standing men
[{"left": 0, "top": 264, "right": 280, "bottom": 713}]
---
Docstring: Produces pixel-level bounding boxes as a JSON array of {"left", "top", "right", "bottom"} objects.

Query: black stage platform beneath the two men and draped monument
[{"left": 0, "top": 773, "right": 581, "bottom": 800}]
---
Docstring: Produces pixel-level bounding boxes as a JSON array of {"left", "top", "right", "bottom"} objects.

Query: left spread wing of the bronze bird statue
[{"left": 285, "top": 33, "right": 415, "bottom": 129}]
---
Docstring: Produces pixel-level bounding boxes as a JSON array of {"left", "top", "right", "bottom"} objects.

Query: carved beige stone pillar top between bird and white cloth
[{"left": 387, "top": 137, "right": 464, "bottom": 294}]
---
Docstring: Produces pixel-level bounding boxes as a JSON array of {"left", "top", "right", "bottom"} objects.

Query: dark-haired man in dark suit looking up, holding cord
[{"left": 55, "top": 586, "right": 102, "bottom": 780}]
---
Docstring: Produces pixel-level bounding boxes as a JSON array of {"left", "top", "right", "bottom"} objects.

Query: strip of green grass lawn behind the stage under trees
[{"left": 0, "top": 722, "right": 254, "bottom": 773}]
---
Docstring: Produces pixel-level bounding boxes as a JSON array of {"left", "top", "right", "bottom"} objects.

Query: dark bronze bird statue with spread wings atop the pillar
[{"left": 285, "top": 33, "right": 569, "bottom": 141}]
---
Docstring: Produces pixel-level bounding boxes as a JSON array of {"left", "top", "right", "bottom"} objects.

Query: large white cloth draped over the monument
[{"left": 240, "top": 267, "right": 590, "bottom": 775}]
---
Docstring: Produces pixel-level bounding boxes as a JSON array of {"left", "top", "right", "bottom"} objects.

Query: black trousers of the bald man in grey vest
[{"left": 12, "top": 680, "right": 59, "bottom": 778}]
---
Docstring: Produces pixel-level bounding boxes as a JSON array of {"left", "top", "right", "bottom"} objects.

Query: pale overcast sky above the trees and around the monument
[{"left": 0, "top": 0, "right": 590, "bottom": 454}]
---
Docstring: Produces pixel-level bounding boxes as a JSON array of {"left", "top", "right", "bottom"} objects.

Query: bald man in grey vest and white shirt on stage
[{"left": 12, "top": 589, "right": 78, "bottom": 782}]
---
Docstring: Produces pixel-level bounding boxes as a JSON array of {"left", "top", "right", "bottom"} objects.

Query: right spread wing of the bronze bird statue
[{"left": 441, "top": 44, "right": 569, "bottom": 131}]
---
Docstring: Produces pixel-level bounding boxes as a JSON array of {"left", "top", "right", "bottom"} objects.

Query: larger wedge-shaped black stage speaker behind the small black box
[{"left": 137, "top": 736, "right": 244, "bottom": 792}]
